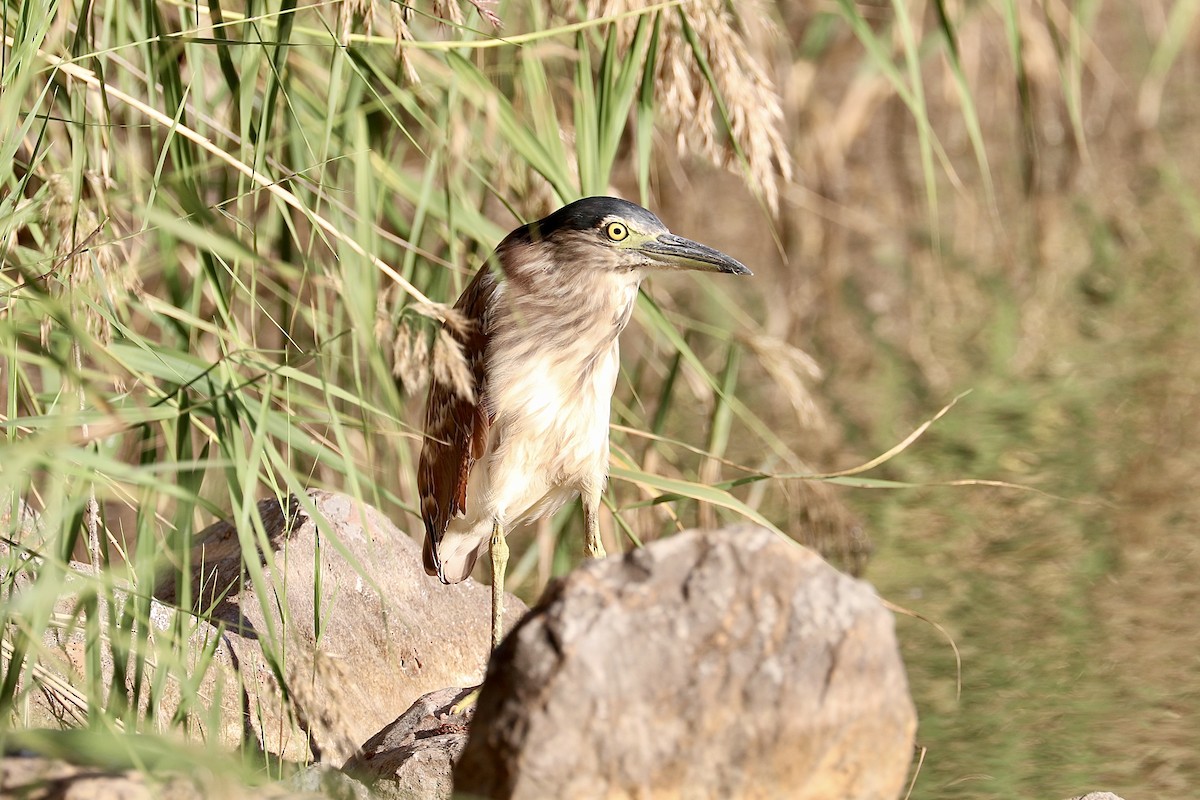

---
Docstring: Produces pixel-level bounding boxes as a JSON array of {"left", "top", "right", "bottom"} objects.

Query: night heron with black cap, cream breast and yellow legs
[{"left": 418, "top": 197, "right": 750, "bottom": 648}]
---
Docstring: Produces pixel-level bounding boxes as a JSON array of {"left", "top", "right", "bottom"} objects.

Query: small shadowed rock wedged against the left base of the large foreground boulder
[{"left": 342, "top": 688, "right": 475, "bottom": 800}]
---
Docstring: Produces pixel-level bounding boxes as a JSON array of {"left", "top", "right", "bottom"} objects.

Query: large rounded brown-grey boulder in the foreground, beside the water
[{"left": 454, "top": 527, "right": 917, "bottom": 800}]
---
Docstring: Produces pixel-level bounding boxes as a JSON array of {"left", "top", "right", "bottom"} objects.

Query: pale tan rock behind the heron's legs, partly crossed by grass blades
[{"left": 155, "top": 492, "right": 526, "bottom": 764}]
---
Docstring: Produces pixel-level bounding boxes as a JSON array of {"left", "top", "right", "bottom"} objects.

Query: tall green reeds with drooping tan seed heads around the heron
[{"left": 0, "top": 2, "right": 825, "bottom": 772}]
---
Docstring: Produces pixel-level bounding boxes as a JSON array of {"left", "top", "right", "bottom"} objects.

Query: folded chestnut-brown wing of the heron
[{"left": 416, "top": 264, "right": 497, "bottom": 577}]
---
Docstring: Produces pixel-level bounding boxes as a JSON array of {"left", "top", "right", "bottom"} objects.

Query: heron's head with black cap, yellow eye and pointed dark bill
[{"left": 499, "top": 197, "right": 751, "bottom": 280}]
